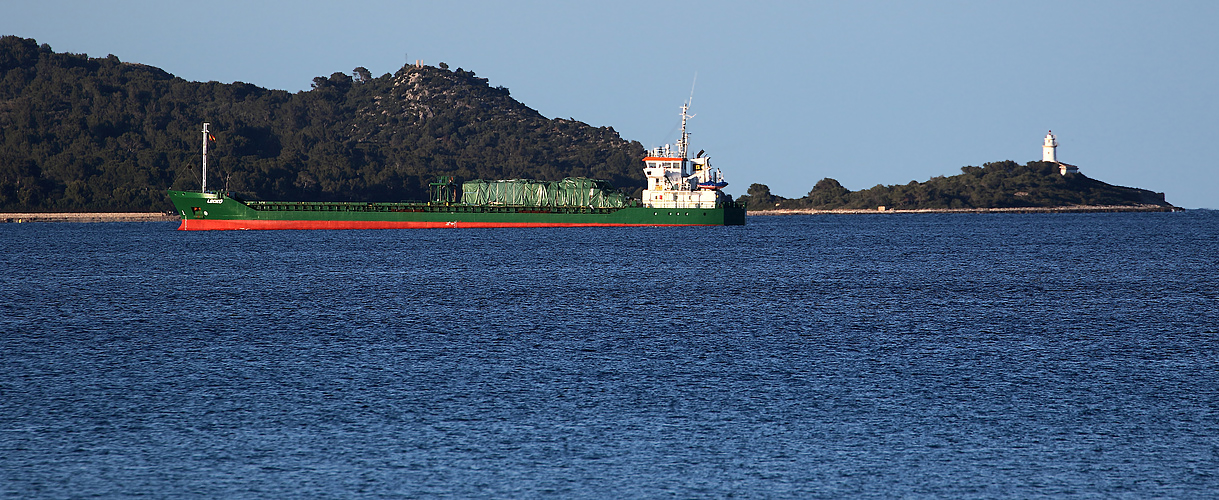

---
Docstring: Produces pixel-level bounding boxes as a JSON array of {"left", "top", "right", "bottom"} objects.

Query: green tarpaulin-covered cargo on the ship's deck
[{"left": 462, "top": 177, "right": 627, "bottom": 209}]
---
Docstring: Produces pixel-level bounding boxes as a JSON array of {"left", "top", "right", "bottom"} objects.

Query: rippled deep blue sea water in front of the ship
[{"left": 0, "top": 211, "right": 1219, "bottom": 499}]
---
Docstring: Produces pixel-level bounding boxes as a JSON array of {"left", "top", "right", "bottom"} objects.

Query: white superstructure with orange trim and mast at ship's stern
[{"left": 642, "top": 102, "right": 728, "bottom": 209}]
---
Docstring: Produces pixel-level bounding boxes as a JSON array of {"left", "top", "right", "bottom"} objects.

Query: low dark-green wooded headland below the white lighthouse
[{"left": 740, "top": 161, "right": 1169, "bottom": 210}]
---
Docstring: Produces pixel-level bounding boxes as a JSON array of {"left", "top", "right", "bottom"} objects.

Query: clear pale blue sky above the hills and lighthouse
[{"left": 0, "top": 0, "right": 1219, "bottom": 209}]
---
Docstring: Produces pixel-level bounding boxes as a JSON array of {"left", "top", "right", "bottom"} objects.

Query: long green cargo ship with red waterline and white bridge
[{"left": 168, "top": 105, "right": 745, "bottom": 230}]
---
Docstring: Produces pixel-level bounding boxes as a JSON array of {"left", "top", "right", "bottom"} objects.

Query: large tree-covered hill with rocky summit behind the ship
[{"left": 0, "top": 37, "right": 645, "bottom": 211}]
